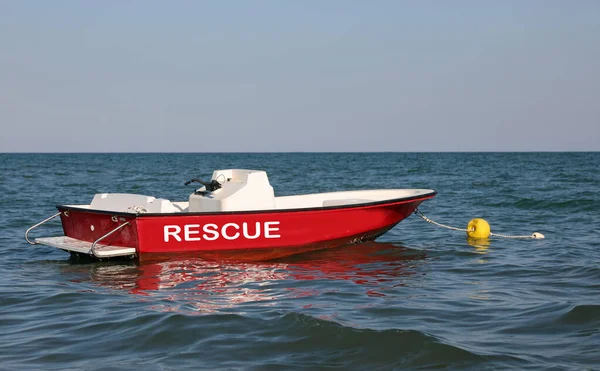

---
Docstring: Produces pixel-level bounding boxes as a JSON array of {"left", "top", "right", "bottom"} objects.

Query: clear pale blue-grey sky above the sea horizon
[{"left": 0, "top": 0, "right": 600, "bottom": 152}]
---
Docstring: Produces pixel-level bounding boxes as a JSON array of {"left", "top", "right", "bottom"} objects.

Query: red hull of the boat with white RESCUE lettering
[{"left": 58, "top": 193, "right": 435, "bottom": 260}]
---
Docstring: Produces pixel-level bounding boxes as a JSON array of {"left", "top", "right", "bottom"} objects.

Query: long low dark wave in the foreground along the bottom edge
[{"left": 0, "top": 310, "right": 521, "bottom": 370}]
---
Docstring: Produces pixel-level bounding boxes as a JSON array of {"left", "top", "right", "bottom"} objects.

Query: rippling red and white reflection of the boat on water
[{"left": 69, "top": 242, "right": 426, "bottom": 312}]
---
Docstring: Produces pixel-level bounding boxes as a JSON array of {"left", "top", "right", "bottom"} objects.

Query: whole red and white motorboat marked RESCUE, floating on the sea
[{"left": 25, "top": 169, "right": 437, "bottom": 260}]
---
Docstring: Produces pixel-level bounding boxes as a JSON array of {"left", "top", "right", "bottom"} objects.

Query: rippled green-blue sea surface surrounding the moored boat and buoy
[{"left": 0, "top": 153, "right": 600, "bottom": 370}]
